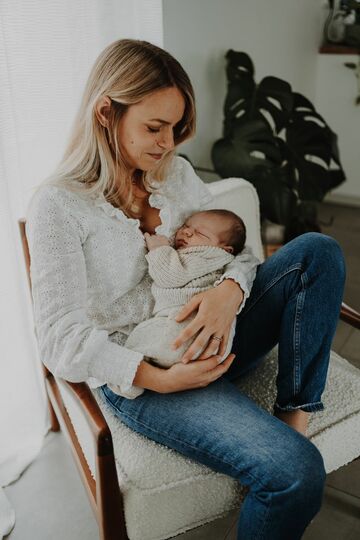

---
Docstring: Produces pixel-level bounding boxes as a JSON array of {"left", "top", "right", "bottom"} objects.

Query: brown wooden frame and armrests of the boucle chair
[{"left": 19, "top": 219, "right": 360, "bottom": 540}]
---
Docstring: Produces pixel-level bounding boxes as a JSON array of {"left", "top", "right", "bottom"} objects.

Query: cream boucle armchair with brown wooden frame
[{"left": 20, "top": 178, "right": 360, "bottom": 540}]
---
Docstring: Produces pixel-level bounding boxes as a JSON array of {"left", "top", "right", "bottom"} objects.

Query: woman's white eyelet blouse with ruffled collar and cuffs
[{"left": 26, "top": 157, "right": 259, "bottom": 392}]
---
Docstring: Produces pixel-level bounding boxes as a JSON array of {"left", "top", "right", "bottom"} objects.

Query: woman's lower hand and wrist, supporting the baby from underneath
[{"left": 157, "top": 354, "right": 235, "bottom": 394}]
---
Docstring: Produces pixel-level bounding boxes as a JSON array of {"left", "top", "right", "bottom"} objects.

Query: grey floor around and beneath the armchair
[{"left": 6, "top": 200, "right": 360, "bottom": 540}]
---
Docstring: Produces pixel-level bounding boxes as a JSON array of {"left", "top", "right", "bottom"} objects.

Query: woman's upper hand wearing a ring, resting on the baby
[{"left": 173, "top": 279, "right": 244, "bottom": 364}]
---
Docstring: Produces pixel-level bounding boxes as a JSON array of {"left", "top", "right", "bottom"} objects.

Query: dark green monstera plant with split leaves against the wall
[{"left": 211, "top": 50, "right": 345, "bottom": 240}]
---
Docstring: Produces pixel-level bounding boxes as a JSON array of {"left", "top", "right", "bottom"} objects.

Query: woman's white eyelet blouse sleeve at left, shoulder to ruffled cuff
[{"left": 26, "top": 187, "right": 144, "bottom": 397}]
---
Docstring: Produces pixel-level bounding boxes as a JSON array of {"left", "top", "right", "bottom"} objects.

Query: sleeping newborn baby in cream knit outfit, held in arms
[{"left": 110, "top": 210, "right": 246, "bottom": 397}]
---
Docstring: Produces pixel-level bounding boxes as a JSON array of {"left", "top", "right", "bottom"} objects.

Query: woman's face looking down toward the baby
[{"left": 118, "top": 87, "right": 185, "bottom": 171}]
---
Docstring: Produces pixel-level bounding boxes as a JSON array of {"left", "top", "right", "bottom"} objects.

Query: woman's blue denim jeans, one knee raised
[{"left": 102, "top": 233, "right": 345, "bottom": 540}]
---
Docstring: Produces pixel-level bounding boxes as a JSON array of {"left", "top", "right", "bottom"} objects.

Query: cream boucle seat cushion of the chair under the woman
[{"left": 81, "top": 349, "right": 360, "bottom": 540}]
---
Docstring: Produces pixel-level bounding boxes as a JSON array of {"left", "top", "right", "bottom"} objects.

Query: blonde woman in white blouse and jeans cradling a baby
[{"left": 27, "top": 40, "right": 344, "bottom": 540}]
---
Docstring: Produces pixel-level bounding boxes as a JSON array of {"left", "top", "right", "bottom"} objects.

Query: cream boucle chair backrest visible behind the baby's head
[{"left": 208, "top": 178, "right": 264, "bottom": 262}]
